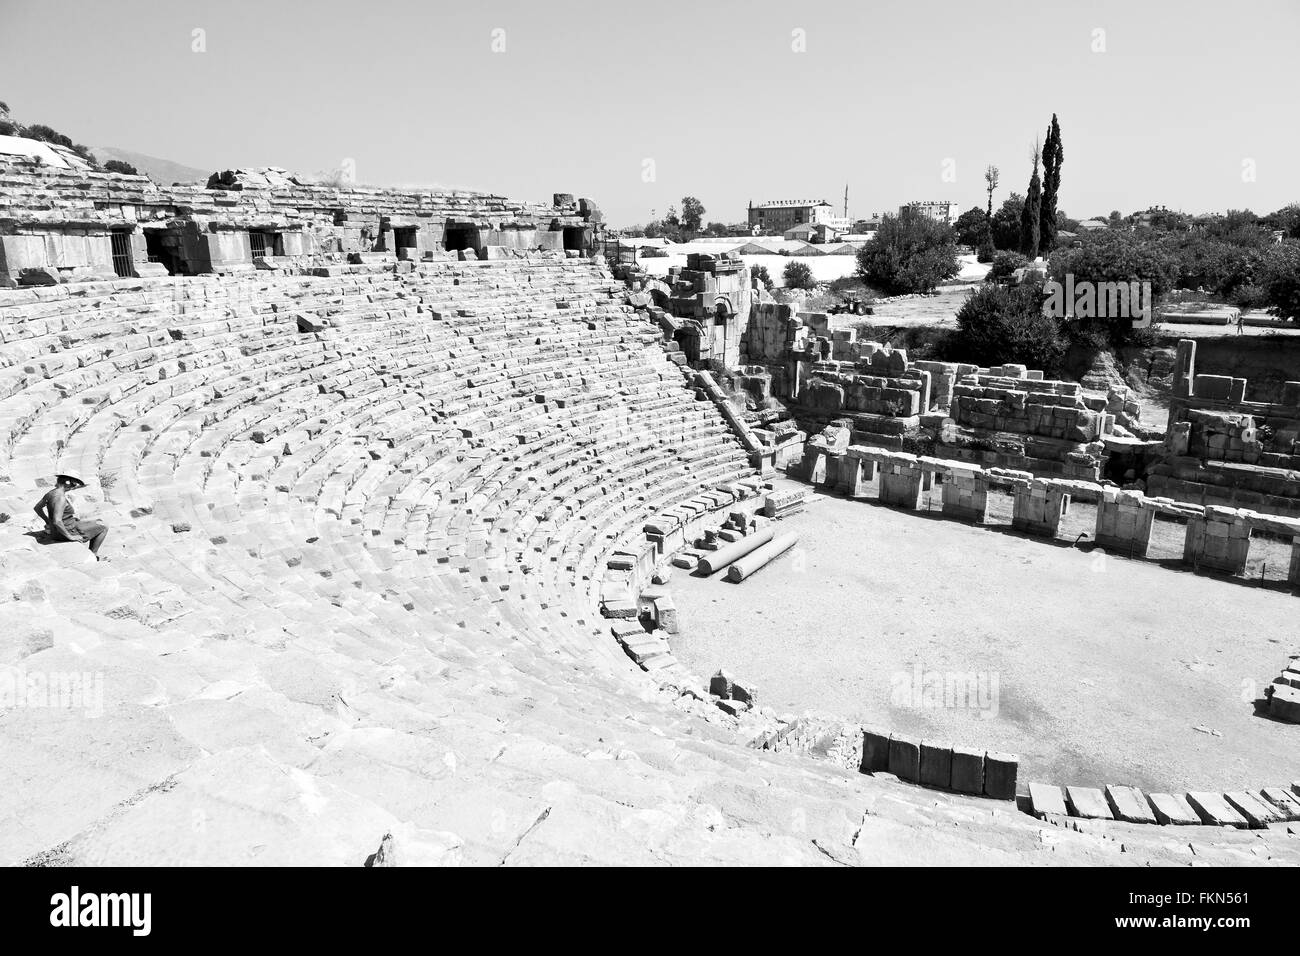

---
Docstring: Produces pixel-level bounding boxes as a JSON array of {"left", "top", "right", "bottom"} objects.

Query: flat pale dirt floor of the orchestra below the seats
[{"left": 672, "top": 488, "right": 1300, "bottom": 791}]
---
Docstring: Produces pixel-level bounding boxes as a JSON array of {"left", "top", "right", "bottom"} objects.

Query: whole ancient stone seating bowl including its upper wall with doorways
[{"left": 0, "top": 168, "right": 1300, "bottom": 865}]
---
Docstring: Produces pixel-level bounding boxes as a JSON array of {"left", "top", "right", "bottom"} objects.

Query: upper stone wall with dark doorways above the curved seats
[{"left": 0, "top": 160, "right": 603, "bottom": 287}]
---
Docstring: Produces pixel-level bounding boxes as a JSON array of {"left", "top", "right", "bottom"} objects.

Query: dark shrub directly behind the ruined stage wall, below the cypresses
[{"left": 952, "top": 284, "right": 1069, "bottom": 373}]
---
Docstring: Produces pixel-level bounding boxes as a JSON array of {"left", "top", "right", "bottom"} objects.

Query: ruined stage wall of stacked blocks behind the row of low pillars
[{"left": 736, "top": 302, "right": 1300, "bottom": 515}]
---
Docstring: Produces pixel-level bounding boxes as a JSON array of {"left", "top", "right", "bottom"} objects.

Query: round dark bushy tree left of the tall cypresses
[{"left": 858, "top": 216, "right": 959, "bottom": 295}]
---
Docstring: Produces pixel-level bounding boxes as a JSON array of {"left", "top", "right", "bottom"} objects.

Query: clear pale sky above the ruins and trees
[{"left": 0, "top": 0, "right": 1300, "bottom": 225}]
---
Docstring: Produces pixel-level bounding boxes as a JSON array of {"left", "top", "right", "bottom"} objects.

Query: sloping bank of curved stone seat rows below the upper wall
[{"left": 0, "top": 257, "right": 1284, "bottom": 864}]
